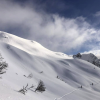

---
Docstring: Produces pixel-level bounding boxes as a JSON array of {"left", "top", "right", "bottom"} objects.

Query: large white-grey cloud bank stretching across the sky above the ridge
[{"left": 0, "top": 1, "right": 100, "bottom": 52}]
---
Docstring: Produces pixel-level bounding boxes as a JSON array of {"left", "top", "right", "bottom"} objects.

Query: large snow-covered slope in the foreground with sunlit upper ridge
[{"left": 0, "top": 32, "right": 100, "bottom": 100}]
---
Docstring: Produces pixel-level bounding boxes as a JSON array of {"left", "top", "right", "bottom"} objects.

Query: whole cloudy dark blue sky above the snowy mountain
[{"left": 0, "top": 0, "right": 100, "bottom": 54}]
